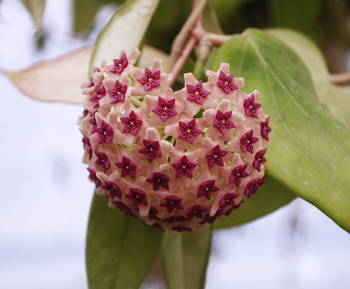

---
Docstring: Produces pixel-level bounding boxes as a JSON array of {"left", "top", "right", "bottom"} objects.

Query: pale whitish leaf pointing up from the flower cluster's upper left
[{"left": 89, "top": 0, "right": 159, "bottom": 72}]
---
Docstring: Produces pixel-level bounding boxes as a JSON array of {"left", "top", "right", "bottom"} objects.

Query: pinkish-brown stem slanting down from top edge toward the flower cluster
[{"left": 170, "top": 0, "right": 207, "bottom": 67}]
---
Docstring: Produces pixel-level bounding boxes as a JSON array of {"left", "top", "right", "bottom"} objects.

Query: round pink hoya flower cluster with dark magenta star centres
[{"left": 79, "top": 51, "right": 271, "bottom": 231}]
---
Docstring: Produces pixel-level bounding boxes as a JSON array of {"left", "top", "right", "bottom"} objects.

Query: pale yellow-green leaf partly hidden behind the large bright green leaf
[{"left": 268, "top": 29, "right": 350, "bottom": 127}]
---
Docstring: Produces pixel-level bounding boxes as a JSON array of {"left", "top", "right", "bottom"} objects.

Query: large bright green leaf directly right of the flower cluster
[{"left": 211, "top": 29, "right": 350, "bottom": 231}]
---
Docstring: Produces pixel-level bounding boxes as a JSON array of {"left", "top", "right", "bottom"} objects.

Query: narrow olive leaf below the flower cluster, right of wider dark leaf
[{"left": 161, "top": 226, "right": 212, "bottom": 289}]
